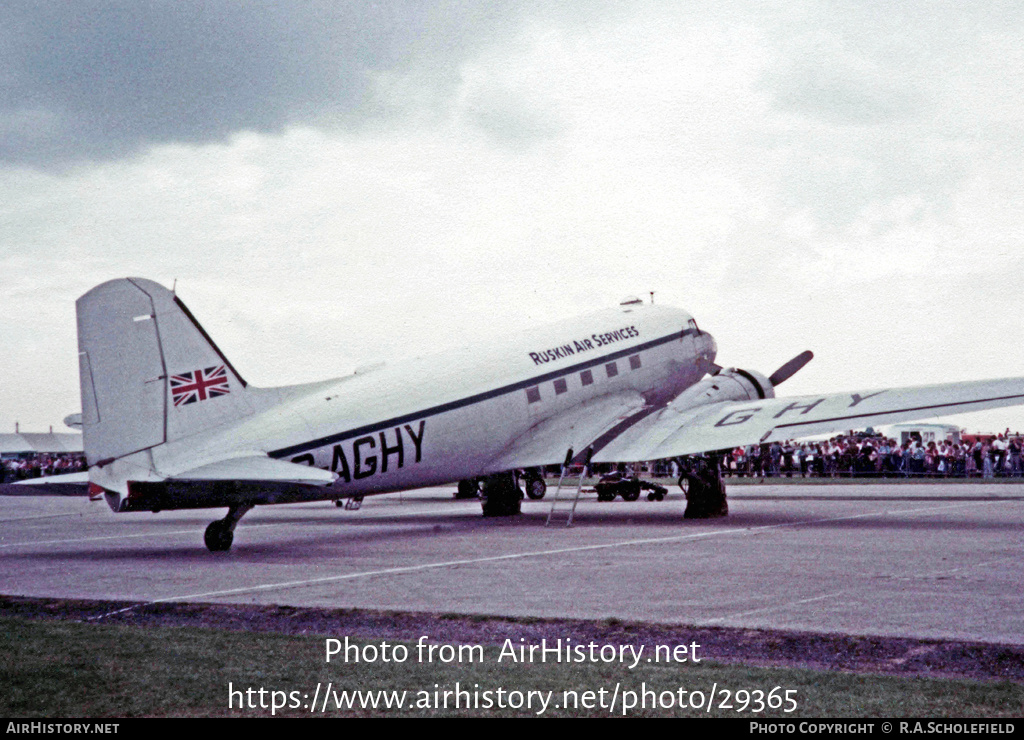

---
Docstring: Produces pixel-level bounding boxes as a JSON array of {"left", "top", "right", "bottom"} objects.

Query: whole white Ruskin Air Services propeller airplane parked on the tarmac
[{"left": 77, "top": 277, "right": 1024, "bottom": 552}]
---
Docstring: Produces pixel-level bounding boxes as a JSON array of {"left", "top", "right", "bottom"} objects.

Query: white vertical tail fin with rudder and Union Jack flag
[{"left": 77, "top": 277, "right": 253, "bottom": 466}]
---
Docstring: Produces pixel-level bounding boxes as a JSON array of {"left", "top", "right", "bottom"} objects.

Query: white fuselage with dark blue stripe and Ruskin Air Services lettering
[{"left": 153, "top": 305, "right": 716, "bottom": 497}]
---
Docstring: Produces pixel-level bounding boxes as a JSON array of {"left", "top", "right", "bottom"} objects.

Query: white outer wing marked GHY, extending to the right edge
[{"left": 594, "top": 378, "right": 1024, "bottom": 463}]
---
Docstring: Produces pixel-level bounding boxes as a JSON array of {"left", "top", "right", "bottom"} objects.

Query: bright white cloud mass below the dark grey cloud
[{"left": 0, "top": 4, "right": 1024, "bottom": 429}]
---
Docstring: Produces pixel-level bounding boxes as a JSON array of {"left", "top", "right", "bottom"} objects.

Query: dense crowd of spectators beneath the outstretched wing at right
[{"left": 719, "top": 430, "right": 1024, "bottom": 478}]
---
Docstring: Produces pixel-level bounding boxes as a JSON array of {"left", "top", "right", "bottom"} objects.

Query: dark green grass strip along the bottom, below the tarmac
[{"left": 0, "top": 617, "right": 1024, "bottom": 719}]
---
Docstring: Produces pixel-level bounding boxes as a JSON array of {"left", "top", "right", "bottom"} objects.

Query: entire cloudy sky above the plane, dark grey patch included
[{"left": 0, "top": 0, "right": 1024, "bottom": 432}]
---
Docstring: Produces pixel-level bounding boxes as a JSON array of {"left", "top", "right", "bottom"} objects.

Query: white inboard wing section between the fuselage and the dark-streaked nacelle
[{"left": 487, "top": 391, "right": 645, "bottom": 470}]
